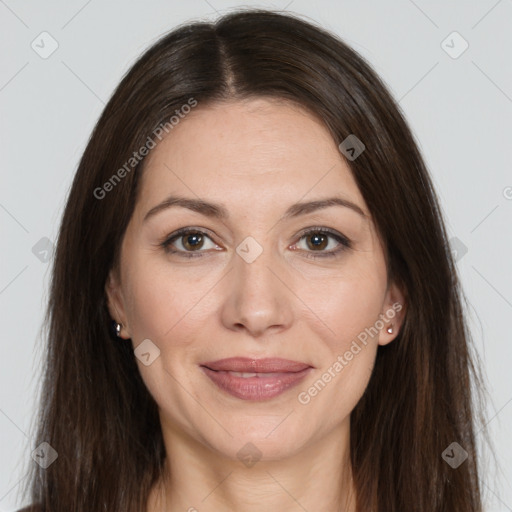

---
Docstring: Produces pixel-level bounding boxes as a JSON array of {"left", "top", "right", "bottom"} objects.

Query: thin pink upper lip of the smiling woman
[{"left": 201, "top": 357, "right": 311, "bottom": 373}]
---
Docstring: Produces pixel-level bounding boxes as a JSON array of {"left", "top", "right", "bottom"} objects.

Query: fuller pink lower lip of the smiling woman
[{"left": 201, "top": 366, "right": 313, "bottom": 400}]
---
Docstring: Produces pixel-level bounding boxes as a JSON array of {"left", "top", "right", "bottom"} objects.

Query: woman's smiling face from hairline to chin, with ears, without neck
[{"left": 107, "top": 99, "right": 403, "bottom": 460}]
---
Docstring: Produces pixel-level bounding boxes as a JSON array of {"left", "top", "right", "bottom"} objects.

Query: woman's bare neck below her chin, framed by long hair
[{"left": 148, "top": 421, "right": 356, "bottom": 512}]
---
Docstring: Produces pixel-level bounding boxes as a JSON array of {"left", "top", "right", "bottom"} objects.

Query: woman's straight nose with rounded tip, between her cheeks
[{"left": 221, "top": 242, "right": 294, "bottom": 338}]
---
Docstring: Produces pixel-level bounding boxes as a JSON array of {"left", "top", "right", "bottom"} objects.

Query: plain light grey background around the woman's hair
[{"left": 0, "top": 0, "right": 512, "bottom": 512}]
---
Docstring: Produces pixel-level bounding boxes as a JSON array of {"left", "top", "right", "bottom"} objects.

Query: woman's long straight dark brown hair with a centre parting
[{"left": 20, "top": 10, "right": 488, "bottom": 512}]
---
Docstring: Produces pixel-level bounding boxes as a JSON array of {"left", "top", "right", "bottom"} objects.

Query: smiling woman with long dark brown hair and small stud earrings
[{"left": 18, "top": 11, "right": 488, "bottom": 512}]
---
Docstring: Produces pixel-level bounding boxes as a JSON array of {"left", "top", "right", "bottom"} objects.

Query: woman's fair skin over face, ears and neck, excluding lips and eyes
[{"left": 106, "top": 99, "right": 404, "bottom": 512}]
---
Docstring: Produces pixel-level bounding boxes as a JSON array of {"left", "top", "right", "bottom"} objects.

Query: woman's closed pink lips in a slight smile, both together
[{"left": 200, "top": 357, "right": 313, "bottom": 401}]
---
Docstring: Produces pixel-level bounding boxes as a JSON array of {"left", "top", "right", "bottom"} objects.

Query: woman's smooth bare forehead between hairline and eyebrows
[{"left": 134, "top": 98, "right": 366, "bottom": 218}]
